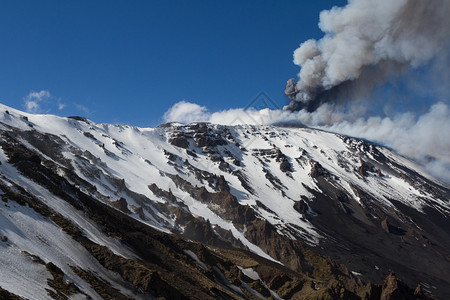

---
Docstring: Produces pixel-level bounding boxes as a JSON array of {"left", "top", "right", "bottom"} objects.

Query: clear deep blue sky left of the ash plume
[{"left": 0, "top": 0, "right": 346, "bottom": 126}]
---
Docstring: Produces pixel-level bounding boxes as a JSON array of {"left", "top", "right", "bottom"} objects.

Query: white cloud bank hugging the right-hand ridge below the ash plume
[{"left": 316, "top": 102, "right": 450, "bottom": 183}]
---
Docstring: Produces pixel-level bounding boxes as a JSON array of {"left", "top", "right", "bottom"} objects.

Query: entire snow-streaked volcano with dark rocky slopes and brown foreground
[{"left": 0, "top": 105, "right": 450, "bottom": 299}]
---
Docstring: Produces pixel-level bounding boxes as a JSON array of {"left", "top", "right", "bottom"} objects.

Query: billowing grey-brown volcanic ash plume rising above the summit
[{"left": 285, "top": 0, "right": 450, "bottom": 111}]
